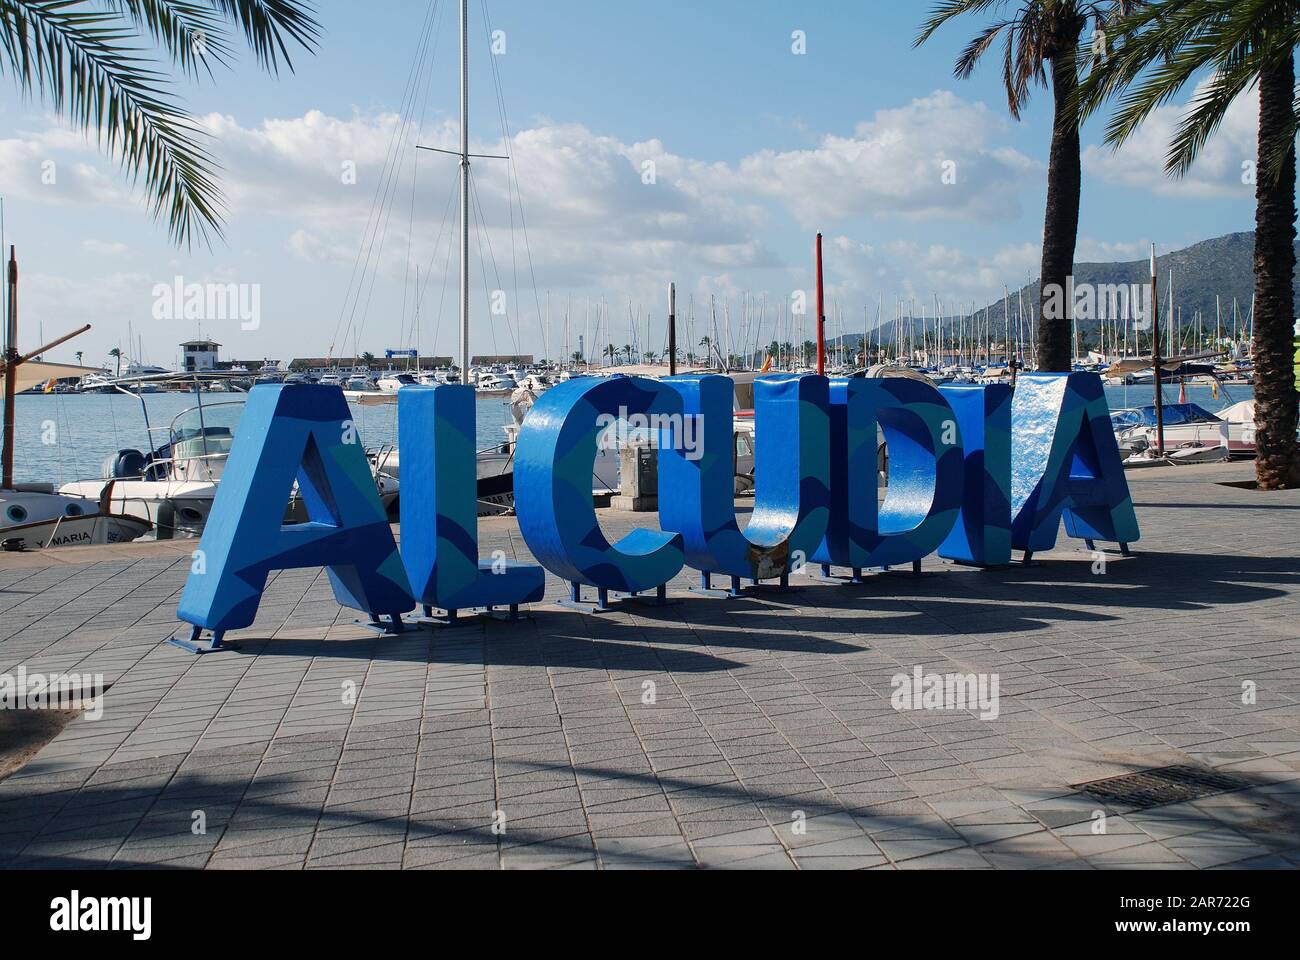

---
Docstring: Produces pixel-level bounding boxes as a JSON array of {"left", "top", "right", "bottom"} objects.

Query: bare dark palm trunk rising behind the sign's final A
[{"left": 1039, "top": 45, "right": 1082, "bottom": 371}]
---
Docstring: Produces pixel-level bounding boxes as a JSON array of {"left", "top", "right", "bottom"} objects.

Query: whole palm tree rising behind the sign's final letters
[{"left": 915, "top": 0, "right": 1141, "bottom": 371}]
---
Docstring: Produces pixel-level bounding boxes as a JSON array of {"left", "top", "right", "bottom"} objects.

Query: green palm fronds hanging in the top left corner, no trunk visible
[{"left": 0, "top": 0, "right": 320, "bottom": 246}]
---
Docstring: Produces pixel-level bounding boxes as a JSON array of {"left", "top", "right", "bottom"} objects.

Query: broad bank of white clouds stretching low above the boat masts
[{"left": 0, "top": 92, "right": 1118, "bottom": 355}]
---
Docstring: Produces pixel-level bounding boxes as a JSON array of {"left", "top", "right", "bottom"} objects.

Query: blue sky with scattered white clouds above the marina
[{"left": 0, "top": 0, "right": 1255, "bottom": 366}]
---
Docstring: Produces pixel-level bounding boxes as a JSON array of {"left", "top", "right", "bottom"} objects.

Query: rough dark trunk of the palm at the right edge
[{"left": 1255, "top": 56, "right": 1300, "bottom": 490}]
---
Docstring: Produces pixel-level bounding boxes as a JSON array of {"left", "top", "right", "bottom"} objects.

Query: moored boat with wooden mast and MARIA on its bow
[{"left": 0, "top": 247, "right": 152, "bottom": 552}]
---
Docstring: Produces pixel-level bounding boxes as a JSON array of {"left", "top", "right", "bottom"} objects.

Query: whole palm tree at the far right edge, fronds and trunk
[{"left": 1079, "top": 0, "right": 1300, "bottom": 490}]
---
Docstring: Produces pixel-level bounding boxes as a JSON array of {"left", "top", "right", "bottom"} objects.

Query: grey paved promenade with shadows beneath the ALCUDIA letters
[{"left": 0, "top": 464, "right": 1300, "bottom": 869}]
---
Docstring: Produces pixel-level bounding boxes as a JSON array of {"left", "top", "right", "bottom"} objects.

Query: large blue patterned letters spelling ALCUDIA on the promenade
[{"left": 177, "top": 373, "right": 1139, "bottom": 636}]
